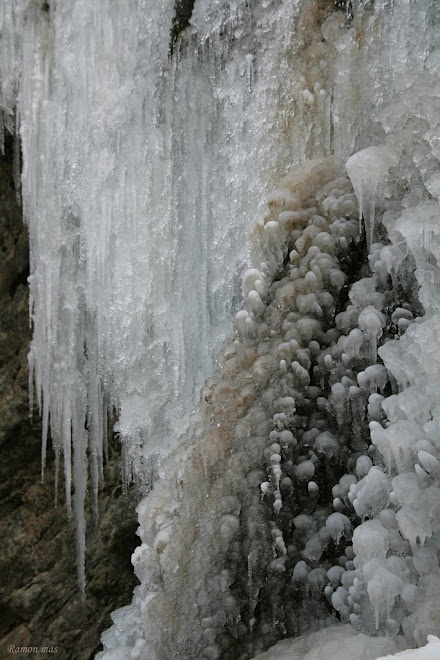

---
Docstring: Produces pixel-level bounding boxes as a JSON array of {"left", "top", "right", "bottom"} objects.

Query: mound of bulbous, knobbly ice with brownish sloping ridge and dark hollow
[{"left": 99, "top": 159, "right": 440, "bottom": 660}]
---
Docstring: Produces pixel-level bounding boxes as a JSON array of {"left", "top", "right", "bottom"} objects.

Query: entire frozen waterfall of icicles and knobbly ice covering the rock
[{"left": 0, "top": 0, "right": 440, "bottom": 660}]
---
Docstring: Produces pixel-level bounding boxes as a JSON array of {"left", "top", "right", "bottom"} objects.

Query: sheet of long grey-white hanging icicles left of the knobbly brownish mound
[{"left": 0, "top": 0, "right": 342, "bottom": 592}]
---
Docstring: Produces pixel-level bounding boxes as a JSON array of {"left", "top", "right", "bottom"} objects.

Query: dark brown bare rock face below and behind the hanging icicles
[{"left": 0, "top": 134, "right": 137, "bottom": 659}]
